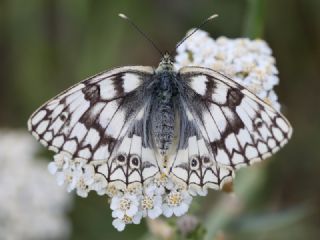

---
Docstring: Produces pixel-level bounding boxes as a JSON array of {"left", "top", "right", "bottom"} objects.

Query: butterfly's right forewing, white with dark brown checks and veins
[{"left": 178, "top": 67, "right": 292, "bottom": 169}]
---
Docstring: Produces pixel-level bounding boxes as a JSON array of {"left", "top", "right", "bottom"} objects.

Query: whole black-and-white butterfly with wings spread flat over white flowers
[{"left": 28, "top": 48, "right": 292, "bottom": 193}]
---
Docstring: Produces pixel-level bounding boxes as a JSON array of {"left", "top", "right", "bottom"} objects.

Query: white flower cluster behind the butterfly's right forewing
[{"left": 175, "top": 30, "right": 280, "bottom": 110}]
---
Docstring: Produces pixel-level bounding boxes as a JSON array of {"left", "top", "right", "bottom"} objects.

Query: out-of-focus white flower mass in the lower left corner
[{"left": 0, "top": 130, "right": 71, "bottom": 240}]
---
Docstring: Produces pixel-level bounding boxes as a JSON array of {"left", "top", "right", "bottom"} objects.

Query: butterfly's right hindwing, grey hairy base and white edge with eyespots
[{"left": 169, "top": 92, "right": 234, "bottom": 195}]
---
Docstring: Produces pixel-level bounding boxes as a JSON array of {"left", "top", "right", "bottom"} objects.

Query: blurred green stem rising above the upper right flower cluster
[{"left": 243, "top": 0, "right": 266, "bottom": 39}]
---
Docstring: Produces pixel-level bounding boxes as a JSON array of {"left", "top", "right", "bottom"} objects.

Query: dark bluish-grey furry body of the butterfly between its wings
[{"left": 151, "top": 54, "right": 177, "bottom": 155}]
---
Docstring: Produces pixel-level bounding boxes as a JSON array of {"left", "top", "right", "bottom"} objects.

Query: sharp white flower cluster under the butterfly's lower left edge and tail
[{"left": 48, "top": 153, "right": 195, "bottom": 231}]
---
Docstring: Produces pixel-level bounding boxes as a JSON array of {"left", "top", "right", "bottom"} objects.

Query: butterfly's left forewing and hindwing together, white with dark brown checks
[{"left": 28, "top": 66, "right": 158, "bottom": 187}]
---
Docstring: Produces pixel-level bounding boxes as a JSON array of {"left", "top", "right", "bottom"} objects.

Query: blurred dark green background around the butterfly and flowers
[{"left": 0, "top": 0, "right": 320, "bottom": 240}]
